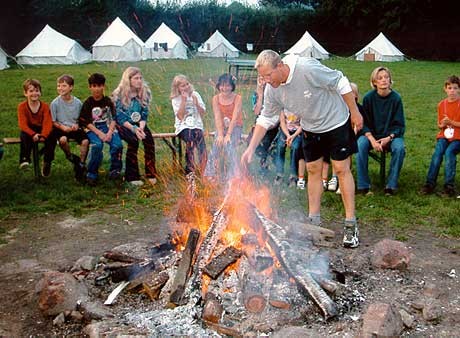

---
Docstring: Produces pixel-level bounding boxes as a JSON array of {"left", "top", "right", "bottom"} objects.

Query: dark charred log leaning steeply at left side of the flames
[{"left": 168, "top": 229, "right": 200, "bottom": 307}]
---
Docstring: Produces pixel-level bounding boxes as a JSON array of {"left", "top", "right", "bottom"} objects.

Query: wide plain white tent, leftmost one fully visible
[{"left": 16, "top": 25, "right": 91, "bottom": 65}]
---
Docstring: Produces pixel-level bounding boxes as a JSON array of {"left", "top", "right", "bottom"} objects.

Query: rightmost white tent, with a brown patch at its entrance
[{"left": 355, "top": 32, "right": 404, "bottom": 61}]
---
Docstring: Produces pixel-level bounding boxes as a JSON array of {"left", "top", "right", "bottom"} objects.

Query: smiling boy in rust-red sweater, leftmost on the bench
[{"left": 18, "top": 79, "right": 56, "bottom": 177}]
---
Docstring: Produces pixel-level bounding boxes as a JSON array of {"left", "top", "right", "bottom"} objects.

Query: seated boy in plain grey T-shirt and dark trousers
[{"left": 51, "top": 74, "right": 89, "bottom": 180}]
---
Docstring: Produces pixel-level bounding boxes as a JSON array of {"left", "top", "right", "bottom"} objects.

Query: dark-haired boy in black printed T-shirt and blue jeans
[{"left": 80, "top": 73, "right": 123, "bottom": 186}]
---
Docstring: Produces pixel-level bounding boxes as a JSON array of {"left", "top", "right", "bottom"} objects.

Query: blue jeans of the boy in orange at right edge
[{"left": 426, "top": 138, "right": 460, "bottom": 186}]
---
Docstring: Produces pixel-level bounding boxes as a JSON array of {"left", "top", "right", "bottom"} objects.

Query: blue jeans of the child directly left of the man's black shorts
[{"left": 275, "top": 129, "right": 303, "bottom": 177}]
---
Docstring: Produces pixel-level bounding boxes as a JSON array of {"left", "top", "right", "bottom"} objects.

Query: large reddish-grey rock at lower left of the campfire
[{"left": 37, "top": 271, "right": 88, "bottom": 316}]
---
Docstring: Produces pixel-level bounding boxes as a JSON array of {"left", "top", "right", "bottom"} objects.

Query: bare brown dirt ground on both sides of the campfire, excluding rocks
[{"left": 0, "top": 207, "right": 460, "bottom": 337}]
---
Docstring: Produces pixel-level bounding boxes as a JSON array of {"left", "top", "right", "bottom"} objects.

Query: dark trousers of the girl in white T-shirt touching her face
[{"left": 179, "top": 129, "right": 208, "bottom": 174}]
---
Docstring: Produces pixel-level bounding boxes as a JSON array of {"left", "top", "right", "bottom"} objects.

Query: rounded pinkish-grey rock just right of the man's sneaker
[{"left": 371, "top": 239, "right": 410, "bottom": 271}]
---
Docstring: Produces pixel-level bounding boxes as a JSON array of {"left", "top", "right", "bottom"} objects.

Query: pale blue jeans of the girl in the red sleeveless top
[{"left": 204, "top": 126, "right": 243, "bottom": 180}]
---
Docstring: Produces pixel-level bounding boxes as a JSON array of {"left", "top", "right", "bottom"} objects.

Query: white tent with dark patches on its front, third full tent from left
[{"left": 145, "top": 22, "right": 187, "bottom": 59}]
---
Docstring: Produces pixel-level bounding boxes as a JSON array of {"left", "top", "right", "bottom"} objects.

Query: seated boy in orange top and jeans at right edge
[{"left": 422, "top": 75, "right": 460, "bottom": 197}]
